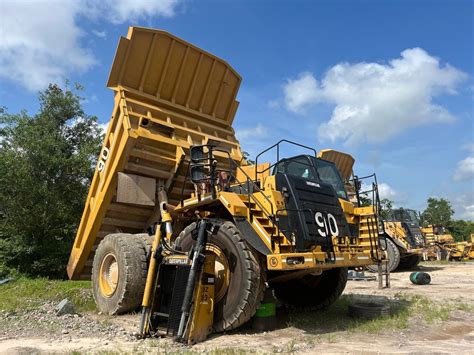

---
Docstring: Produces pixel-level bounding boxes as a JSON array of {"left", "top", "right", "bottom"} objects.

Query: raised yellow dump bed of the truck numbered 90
[{"left": 67, "top": 27, "right": 242, "bottom": 279}]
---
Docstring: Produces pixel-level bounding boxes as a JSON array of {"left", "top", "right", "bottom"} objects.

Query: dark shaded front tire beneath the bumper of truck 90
[{"left": 271, "top": 268, "right": 347, "bottom": 310}]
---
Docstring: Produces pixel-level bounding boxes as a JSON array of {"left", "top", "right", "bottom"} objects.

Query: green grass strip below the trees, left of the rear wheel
[{"left": 0, "top": 278, "right": 96, "bottom": 312}]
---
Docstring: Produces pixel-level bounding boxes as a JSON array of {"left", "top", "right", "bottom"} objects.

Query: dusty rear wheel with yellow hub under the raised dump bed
[{"left": 92, "top": 233, "right": 147, "bottom": 314}]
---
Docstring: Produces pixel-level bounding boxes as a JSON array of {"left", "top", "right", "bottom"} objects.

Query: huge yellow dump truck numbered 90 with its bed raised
[{"left": 67, "top": 27, "right": 380, "bottom": 331}]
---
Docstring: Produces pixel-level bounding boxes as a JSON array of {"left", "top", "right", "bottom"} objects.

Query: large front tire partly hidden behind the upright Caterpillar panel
[{"left": 175, "top": 221, "right": 265, "bottom": 332}]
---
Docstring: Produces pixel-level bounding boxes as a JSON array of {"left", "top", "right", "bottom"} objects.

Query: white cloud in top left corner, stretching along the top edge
[{"left": 0, "top": 0, "right": 178, "bottom": 91}]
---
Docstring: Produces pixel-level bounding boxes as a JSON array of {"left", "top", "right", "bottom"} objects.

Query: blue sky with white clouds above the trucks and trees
[{"left": 0, "top": 0, "right": 474, "bottom": 220}]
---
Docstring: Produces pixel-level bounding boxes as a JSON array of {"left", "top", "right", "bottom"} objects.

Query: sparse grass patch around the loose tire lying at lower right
[{"left": 288, "top": 295, "right": 474, "bottom": 334}]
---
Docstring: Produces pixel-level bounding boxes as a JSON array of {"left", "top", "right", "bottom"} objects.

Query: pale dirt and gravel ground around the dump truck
[{"left": 0, "top": 262, "right": 474, "bottom": 354}]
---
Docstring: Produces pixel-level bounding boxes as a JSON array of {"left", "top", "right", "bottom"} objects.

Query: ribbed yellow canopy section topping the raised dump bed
[{"left": 107, "top": 27, "right": 241, "bottom": 127}]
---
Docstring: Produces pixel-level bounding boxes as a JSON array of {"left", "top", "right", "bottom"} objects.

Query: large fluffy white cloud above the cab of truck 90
[{"left": 283, "top": 48, "right": 467, "bottom": 144}]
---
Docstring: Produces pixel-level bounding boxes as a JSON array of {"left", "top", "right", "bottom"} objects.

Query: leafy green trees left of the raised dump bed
[{"left": 0, "top": 84, "right": 102, "bottom": 277}]
